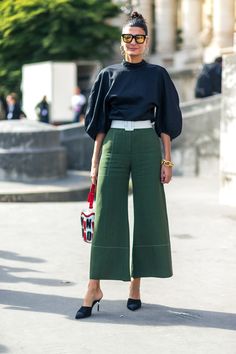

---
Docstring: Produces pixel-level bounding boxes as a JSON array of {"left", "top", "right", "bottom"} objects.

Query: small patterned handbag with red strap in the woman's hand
[{"left": 81, "top": 184, "right": 96, "bottom": 243}]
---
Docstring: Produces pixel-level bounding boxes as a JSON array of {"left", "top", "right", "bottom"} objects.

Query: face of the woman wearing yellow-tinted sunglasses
[{"left": 121, "top": 26, "right": 148, "bottom": 57}]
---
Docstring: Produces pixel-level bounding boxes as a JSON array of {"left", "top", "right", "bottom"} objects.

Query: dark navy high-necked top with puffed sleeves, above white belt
[{"left": 85, "top": 60, "right": 182, "bottom": 140}]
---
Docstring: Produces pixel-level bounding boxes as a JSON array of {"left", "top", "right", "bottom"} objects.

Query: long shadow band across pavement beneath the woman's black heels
[{"left": 0, "top": 290, "right": 236, "bottom": 330}]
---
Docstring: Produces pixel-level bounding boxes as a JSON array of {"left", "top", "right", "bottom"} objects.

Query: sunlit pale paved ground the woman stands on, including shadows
[{"left": 0, "top": 178, "right": 236, "bottom": 354}]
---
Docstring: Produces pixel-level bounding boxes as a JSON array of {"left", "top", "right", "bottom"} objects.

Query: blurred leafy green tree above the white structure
[{"left": 0, "top": 0, "right": 120, "bottom": 91}]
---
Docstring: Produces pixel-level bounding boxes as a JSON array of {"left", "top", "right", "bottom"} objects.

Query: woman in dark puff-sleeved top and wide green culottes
[{"left": 76, "top": 12, "right": 182, "bottom": 319}]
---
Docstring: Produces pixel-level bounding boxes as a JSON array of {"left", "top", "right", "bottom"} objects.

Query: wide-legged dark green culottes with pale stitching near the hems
[{"left": 90, "top": 128, "right": 172, "bottom": 281}]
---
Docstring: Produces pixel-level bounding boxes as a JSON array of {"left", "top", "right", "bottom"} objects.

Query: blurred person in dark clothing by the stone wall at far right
[{"left": 195, "top": 57, "right": 222, "bottom": 98}]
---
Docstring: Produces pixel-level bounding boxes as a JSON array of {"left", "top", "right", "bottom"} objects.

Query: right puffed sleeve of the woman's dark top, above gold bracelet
[{"left": 155, "top": 68, "right": 182, "bottom": 140}]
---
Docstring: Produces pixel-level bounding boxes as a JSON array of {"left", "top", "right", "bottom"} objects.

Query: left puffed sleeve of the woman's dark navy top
[{"left": 85, "top": 70, "right": 109, "bottom": 140}]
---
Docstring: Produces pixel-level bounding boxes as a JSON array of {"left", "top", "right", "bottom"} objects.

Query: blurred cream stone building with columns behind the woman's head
[{"left": 113, "top": 0, "right": 236, "bottom": 67}]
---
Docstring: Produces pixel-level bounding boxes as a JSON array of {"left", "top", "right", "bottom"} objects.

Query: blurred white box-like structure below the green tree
[{"left": 22, "top": 62, "right": 77, "bottom": 122}]
